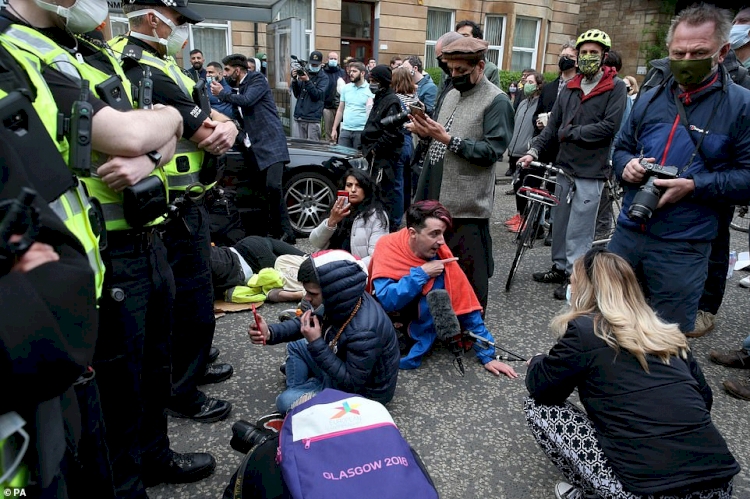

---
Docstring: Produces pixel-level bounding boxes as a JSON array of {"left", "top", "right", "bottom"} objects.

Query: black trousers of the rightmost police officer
[{"left": 164, "top": 202, "right": 216, "bottom": 413}]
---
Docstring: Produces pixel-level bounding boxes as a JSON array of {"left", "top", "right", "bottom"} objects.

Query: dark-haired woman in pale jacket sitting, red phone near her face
[{"left": 310, "top": 168, "right": 388, "bottom": 267}]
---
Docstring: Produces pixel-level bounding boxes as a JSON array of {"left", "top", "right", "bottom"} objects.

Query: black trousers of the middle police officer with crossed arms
[{"left": 93, "top": 232, "right": 175, "bottom": 498}]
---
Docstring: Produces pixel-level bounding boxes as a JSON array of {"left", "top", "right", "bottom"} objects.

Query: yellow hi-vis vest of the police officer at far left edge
[{"left": 0, "top": 37, "right": 105, "bottom": 300}]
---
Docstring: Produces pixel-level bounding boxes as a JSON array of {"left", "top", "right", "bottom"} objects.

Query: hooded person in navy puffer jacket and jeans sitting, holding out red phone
[{"left": 249, "top": 250, "right": 398, "bottom": 413}]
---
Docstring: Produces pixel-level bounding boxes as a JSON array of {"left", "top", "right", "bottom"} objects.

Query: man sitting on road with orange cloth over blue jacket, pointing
[{"left": 370, "top": 200, "right": 518, "bottom": 378}]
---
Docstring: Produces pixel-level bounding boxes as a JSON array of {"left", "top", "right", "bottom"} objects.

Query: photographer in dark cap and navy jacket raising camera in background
[{"left": 292, "top": 50, "right": 328, "bottom": 141}]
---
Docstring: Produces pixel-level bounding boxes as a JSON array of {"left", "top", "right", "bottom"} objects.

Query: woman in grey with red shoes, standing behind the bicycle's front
[{"left": 505, "top": 71, "right": 544, "bottom": 232}]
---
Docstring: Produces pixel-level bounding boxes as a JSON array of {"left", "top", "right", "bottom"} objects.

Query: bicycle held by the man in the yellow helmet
[{"left": 505, "top": 161, "right": 580, "bottom": 291}]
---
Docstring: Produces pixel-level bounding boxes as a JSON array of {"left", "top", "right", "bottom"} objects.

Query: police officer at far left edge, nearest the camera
[{"left": 0, "top": 41, "right": 100, "bottom": 498}]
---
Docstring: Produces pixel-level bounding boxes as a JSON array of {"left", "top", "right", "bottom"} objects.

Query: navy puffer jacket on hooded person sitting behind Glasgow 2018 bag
[{"left": 269, "top": 261, "right": 399, "bottom": 404}]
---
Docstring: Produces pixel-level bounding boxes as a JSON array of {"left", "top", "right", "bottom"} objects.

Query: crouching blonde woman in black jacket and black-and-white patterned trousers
[{"left": 524, "top": 248, "right": 740, "bottom": 499}]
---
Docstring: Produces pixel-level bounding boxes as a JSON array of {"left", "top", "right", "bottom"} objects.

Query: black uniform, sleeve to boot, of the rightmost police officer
[{"left": 123, "top": 37, "right": 231, "bottom": 421}]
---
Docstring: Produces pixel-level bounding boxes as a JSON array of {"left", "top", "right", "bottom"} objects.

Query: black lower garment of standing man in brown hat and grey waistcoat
[{"left": 445, "top": 218, "right": 495, "bottom": 316}]
